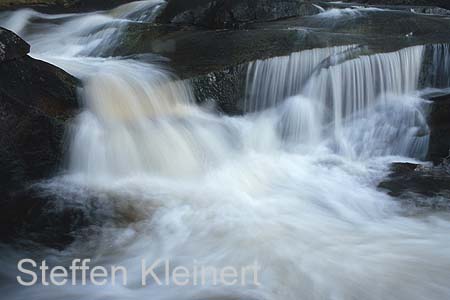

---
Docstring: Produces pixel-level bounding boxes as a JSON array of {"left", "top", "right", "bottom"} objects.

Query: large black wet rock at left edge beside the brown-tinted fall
[{"left": 0, "top": 30, "right": 78, "bottom": 193}]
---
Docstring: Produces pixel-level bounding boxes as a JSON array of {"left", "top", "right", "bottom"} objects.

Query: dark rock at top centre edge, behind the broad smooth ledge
[{"left": 157, "top": 0, "right": 319, "bottom": 28}]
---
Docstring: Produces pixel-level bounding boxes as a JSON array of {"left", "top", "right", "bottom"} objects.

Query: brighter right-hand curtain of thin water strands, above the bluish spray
[{"left": 303, "top": 46, "right": 424, "bottom": 120}]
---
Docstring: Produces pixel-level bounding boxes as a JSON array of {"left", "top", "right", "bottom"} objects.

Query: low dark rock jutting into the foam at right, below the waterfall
[{"left": 379, "top": 163, "right": 450, "bottom": 210}]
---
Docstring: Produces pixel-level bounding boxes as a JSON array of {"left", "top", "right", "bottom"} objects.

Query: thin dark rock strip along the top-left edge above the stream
[{"left": 0, "top": 0, "right": 133, "bottom": 13}]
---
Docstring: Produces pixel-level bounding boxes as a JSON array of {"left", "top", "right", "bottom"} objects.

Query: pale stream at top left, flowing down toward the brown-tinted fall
[{"left": 0, "top": 0, "right": 164, "bottom": 59}]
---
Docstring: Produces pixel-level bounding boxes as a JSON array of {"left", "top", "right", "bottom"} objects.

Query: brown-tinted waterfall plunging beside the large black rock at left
[{"left": 70, "top": 60, "right": 207, "bottom": 181}]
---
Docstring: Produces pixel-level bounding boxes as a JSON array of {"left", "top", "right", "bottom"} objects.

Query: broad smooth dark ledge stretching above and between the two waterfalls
[{"left": 113, "top": 24, "right": 365, "bottom": 79}]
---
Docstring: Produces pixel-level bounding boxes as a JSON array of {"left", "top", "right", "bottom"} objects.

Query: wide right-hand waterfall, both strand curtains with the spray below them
[{"left": 246, "top": 45, "right": 428, "bottom": 158}]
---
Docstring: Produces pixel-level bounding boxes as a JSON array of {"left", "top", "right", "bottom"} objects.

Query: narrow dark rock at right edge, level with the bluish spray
[{"left": 428, "top": 95, "right": 450, "bottom": 164}]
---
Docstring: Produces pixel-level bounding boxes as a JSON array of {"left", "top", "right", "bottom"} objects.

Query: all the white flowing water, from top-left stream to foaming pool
[{"left": 0, "top": 2, "right": 450, "bottom": 300}]
